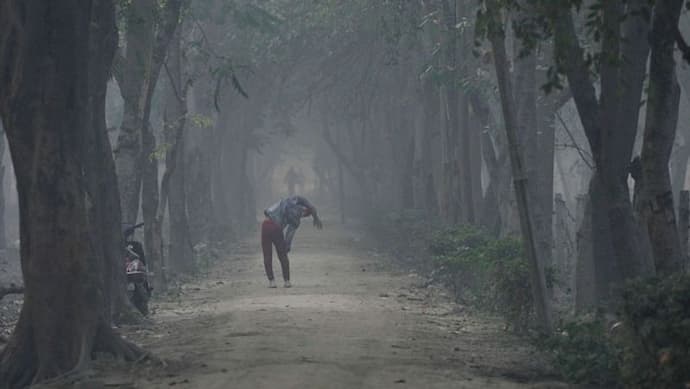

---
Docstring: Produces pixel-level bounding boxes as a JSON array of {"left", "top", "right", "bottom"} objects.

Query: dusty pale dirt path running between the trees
[{"left": 99, "top": 221, "right": 564, "bottom": 389}]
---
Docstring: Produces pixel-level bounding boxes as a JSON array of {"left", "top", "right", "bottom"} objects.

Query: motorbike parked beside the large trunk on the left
[{"left": 124, "top": 223, "right": 153, "bottom": 316}]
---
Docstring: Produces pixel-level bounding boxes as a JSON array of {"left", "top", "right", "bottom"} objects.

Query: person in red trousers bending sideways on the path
[{"left": 261, "top": 196, "right": 323, "bottom": 288}]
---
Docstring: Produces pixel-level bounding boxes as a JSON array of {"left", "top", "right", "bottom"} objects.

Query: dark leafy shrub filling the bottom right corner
[{"left": 544, "top": 274, "right": 690, "bottom": 389}]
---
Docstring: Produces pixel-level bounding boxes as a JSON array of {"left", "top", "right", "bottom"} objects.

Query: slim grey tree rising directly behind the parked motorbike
[{"left": 115, "top": 0, "right": 186, "bottom": 274}]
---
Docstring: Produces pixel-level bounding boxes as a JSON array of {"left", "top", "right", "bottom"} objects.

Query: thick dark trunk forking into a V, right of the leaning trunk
[{"left": 553, "top": 0, "right": 649, "bottom": 302}]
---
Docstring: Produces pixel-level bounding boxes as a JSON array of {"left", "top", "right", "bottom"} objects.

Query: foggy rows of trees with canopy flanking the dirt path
[{"left": 0, "top": 0, "right": 690, "bottom": 387}]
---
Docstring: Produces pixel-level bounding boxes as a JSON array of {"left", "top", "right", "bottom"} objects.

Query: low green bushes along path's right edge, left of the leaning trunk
[{"left": 375, "top": 211, "right": 536, "bottom": 333}]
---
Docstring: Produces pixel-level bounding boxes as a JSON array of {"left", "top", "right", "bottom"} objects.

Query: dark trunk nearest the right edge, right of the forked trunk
[{"left": 640, "top": 0, "right": 685, "bottom": 274}]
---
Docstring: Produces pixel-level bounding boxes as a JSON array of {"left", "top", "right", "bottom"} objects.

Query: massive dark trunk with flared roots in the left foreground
[{"left": 0, "top": 1, "right": 141, "bottom": 388}]
